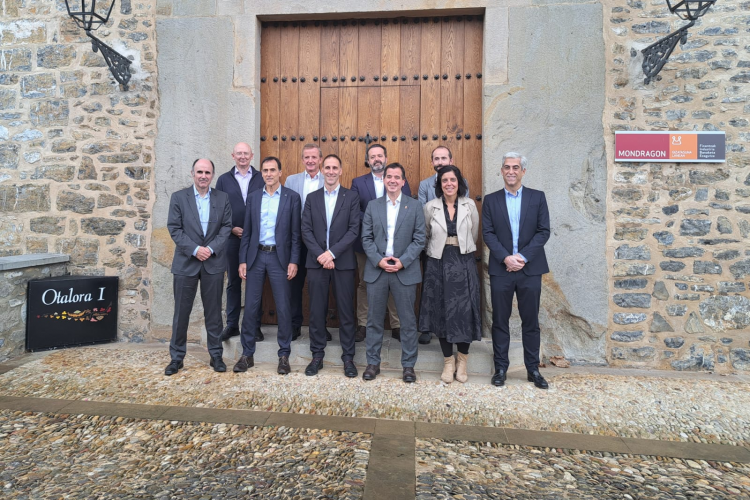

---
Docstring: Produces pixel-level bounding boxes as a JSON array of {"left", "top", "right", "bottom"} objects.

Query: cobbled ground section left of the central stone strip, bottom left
[{"left": 0, "top": 411, "right": 370, "bottom": 500}]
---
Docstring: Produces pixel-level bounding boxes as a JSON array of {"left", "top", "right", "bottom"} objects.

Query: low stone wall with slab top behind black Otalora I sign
[{"left": 0, "top": 254, "right": 68, "bottom": 363}]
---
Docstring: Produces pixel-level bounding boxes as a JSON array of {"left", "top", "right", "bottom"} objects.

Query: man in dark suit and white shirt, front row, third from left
[{"left": 302, "top": 155, "right": 359, "bottom": 377}]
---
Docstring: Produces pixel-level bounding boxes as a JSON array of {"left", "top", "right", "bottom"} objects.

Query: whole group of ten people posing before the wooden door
[{"left": 165, "top": 143, "right": 550, "bottom": 389}]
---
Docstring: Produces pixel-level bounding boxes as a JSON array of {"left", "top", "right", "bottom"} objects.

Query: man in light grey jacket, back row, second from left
[{"left": 284, "top": 144, "right": 331, "bottom": 340}]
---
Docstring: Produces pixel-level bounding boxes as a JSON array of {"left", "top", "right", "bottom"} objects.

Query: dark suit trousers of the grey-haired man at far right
[{"left": 490, "top": 271, "right": 542, "bottom": 372}]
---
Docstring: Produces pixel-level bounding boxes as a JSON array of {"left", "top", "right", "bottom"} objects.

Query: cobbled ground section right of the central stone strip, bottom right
[{"left": 416, "top": 439, "right": 750, "bottom": 500}]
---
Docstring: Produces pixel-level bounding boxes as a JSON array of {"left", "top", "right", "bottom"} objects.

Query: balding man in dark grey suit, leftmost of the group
[{"left": 164, "top": 159, "right": 232, "bottom": 375}]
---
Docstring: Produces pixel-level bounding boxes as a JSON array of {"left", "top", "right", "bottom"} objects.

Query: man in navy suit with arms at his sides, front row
[{"left": 234, "top": 156, "right": 301, "bottom": 375}]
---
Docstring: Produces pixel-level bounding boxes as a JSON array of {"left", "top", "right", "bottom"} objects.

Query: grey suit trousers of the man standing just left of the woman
[{"left": 365, "top": 271, "right": 418, "bottom": 368}]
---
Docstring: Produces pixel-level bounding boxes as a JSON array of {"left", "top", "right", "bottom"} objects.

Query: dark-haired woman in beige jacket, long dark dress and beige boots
[{"left": 419, "top": 165, "right": 482, "bottom": 384}]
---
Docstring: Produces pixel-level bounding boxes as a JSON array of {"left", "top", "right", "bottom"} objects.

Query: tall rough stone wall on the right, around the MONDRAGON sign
[{"left": 603, "top": 0, "right": 750, "bottom": 373}]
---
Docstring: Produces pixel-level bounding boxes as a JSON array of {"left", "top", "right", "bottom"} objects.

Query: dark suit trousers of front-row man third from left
[{"left": 307, "top": 268, "right": 357, "bottom": 361}]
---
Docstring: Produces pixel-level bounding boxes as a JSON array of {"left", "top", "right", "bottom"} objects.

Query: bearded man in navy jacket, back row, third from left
[{"left": 352, "top": 144, "right": 411, "bottom": 342}]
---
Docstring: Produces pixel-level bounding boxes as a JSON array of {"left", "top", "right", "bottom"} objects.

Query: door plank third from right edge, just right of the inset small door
[{"left": 419, "top": 18, "right": 442, "bottom": 186}]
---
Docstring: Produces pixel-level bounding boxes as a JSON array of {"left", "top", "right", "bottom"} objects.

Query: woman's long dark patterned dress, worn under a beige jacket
[{"left": 419, "top": 200, "right": 482, "bottom": 344}]
